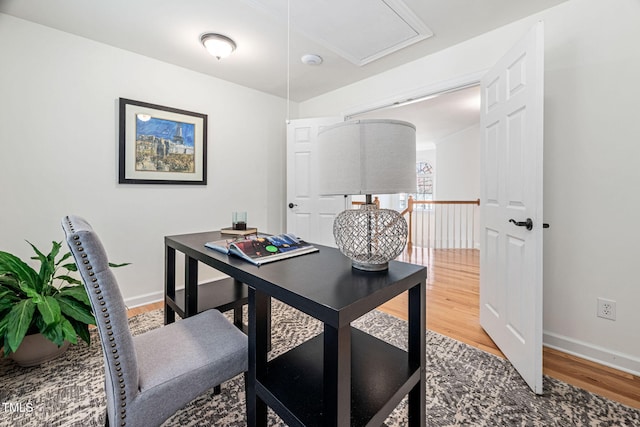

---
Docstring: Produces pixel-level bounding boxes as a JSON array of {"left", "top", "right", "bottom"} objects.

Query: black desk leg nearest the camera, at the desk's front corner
[{"left": 323, "top": 324, "right": 351, "bottom": 427}]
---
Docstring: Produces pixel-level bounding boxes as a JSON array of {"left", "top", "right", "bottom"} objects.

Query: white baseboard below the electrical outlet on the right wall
[{"left": 543, "top": 332, "right": 640, "bottom": 376}]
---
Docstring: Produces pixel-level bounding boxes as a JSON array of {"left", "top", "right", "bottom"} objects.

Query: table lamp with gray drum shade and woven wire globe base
[{"left": 317, "top": 119, "right": 416, "bottom": 271}]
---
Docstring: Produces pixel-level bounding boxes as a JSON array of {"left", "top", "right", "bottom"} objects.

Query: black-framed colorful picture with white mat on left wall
[{"left": 118, "top": 98, "right": 207, "bottom": 185}]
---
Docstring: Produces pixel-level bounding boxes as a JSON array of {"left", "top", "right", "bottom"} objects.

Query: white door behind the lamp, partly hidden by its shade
[{"left": 287, "top": 117, "right": 345, "bottom": 247}]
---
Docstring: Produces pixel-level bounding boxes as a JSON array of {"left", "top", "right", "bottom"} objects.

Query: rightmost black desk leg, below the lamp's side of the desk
[{"left": 409, "top": 282, "right": 426, "bottom": 426}]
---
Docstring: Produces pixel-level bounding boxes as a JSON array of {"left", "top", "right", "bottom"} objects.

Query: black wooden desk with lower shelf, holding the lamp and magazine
[{"left": 165, "top": 232, "right": 426, "bottom": 426}]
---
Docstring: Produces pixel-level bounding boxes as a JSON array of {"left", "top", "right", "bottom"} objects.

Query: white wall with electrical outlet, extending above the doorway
[{"left": 300, "top": 0, "right": 640, "bottom": 374}]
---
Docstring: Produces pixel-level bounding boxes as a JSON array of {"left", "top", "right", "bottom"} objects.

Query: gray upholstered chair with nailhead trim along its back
[{"left": 62, "top": 216, "right": 248, "bottom": 427}]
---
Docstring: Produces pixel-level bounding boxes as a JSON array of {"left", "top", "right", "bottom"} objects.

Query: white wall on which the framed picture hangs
[{"left": 0, "top": 14, "right": 286, "bottom": 305}]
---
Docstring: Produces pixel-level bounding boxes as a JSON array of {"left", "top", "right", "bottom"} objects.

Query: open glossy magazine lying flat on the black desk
[{"left": 205, "top": 233, "right": 318, "bottom": 266}]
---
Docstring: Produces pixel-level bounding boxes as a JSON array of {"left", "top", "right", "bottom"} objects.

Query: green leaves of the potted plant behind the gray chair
[{"left": 0, "top": 242, "right": 127, "bottom": 356}]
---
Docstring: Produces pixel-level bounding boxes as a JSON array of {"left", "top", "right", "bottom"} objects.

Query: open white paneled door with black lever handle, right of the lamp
[{"left": 480, "top": 22, "right": 544, "bottom": 394}]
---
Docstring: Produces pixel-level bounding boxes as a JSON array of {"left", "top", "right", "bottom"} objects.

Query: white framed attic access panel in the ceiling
[{"left": 249, "top": 0, "right": 433, "bottom": 66}]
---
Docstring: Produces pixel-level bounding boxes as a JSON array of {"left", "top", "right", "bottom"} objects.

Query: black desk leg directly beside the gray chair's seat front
[{"left": 245, "top": 287, "right": 264, "bottom": 427}]
